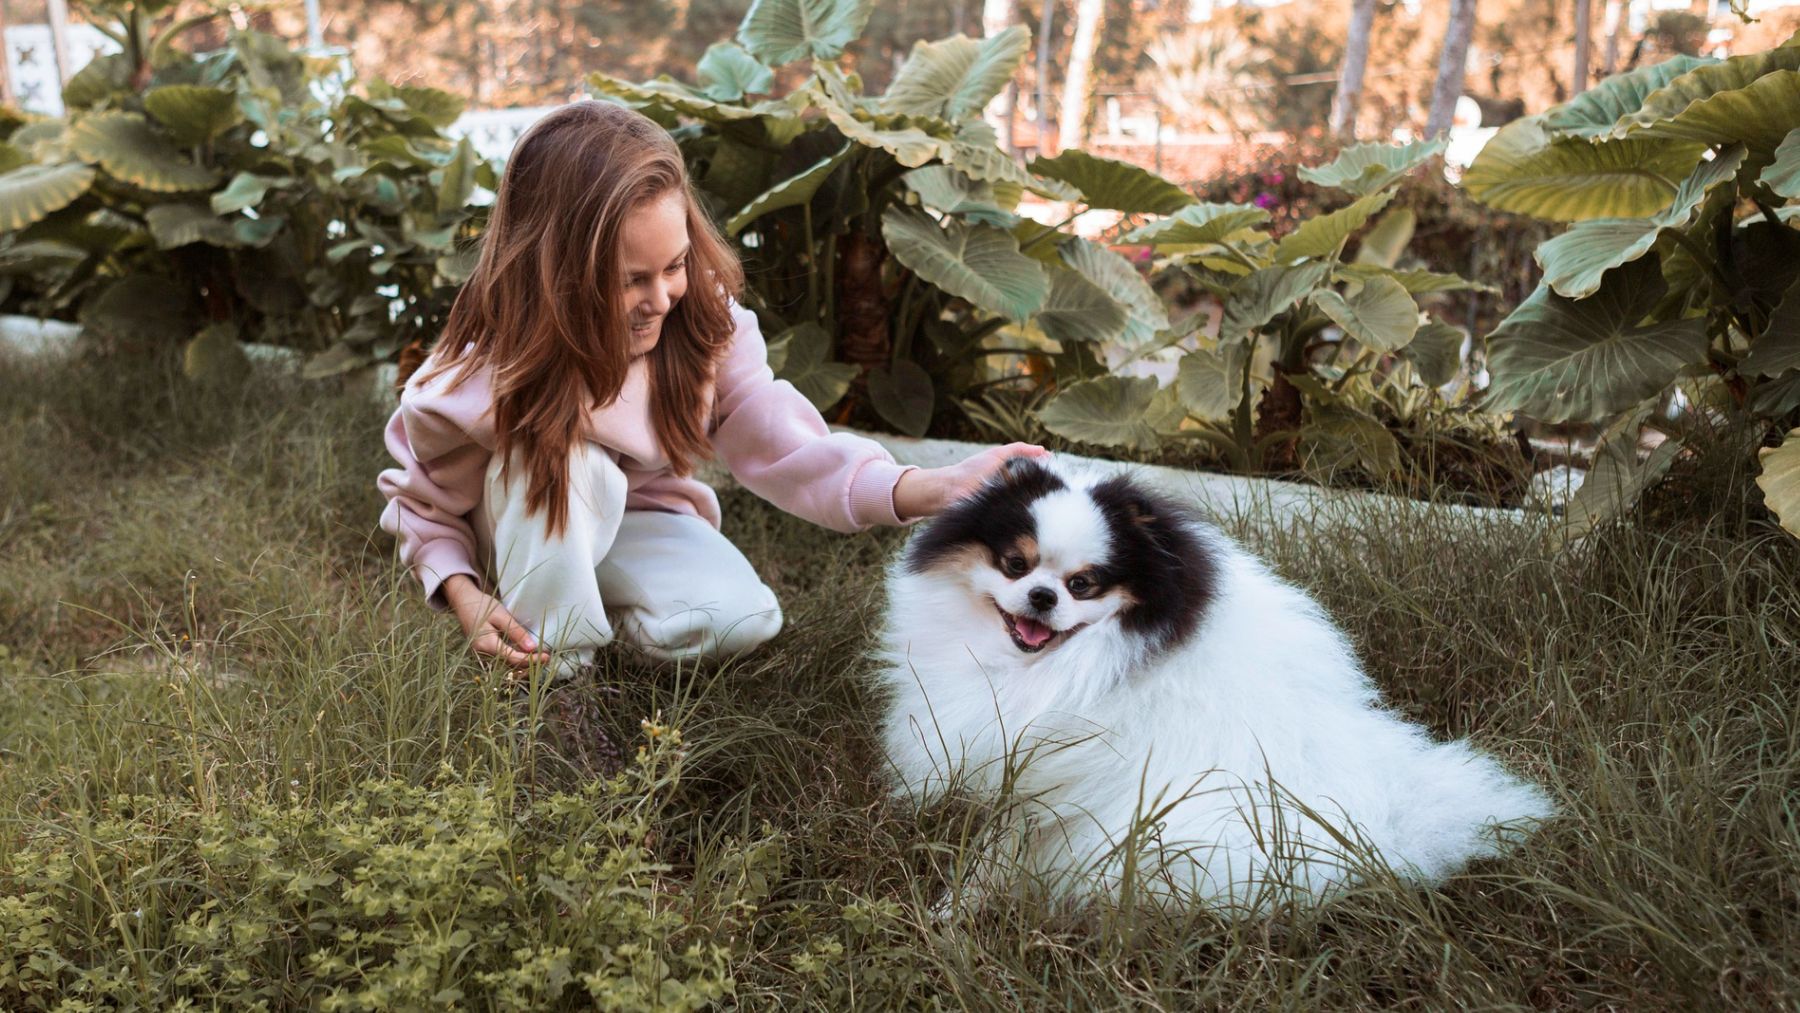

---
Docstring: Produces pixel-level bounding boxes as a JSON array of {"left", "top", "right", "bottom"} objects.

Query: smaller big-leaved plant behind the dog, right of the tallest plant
[{"left": 1080, "top": 142, "right": 1481, "bottom": 480}]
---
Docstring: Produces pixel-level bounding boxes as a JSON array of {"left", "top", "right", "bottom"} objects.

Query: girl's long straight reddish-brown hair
[{"left": 421, "top": 101, "right": 743, "bottom": 533}]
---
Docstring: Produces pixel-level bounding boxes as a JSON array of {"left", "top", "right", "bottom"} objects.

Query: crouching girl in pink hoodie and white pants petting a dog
[{"left": 380, "top": 103, "right": 1046, "bottom": 675}]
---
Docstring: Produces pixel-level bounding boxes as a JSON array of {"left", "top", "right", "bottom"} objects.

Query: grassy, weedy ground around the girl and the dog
[{"left": 0, "top": 352, "right": 1800, "bottom": 1009}]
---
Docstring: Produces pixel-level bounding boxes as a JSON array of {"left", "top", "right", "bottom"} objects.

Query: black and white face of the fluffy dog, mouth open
[{"left": 905, "top": 459, "right": 1213, "bottom": 664}]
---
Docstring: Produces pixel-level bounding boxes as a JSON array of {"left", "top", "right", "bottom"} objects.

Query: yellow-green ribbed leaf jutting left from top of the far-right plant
[{"left": 1462, "top": 117, "right": 1705, "bottom": 221}]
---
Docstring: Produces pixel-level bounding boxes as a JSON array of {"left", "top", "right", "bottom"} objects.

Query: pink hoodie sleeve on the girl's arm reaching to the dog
[{"left": 713, "top": 302, "right": 911, "bottom": 531}]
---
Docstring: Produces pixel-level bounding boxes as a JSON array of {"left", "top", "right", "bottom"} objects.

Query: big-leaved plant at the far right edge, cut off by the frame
[{"left": 1463, "top": 40, "right": 1800, "bottom": 533}]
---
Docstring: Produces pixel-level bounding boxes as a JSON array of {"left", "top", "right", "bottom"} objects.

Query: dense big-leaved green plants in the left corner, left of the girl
[{"left": 0, "top": 4, "right": 493, "bottom": 376}]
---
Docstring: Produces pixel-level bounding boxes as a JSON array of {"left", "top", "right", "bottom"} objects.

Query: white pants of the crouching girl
[{"left": 473, "top": 441, "right": 781, "bottom": 673}]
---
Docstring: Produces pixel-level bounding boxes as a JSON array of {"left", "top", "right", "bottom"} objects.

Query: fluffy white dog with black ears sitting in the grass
[{"left": 877, "top": 461, "right": 1552, "bottom": 910}]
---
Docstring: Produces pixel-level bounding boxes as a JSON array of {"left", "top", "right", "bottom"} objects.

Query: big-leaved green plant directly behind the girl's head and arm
[{"left": 589, "top": 0, "right": 1193, "bottom": 435}]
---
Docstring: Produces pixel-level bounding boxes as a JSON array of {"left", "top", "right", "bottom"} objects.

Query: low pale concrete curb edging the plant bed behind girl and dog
[{"left": 0, "top": 317, "right": 1553, "bottom": 529}]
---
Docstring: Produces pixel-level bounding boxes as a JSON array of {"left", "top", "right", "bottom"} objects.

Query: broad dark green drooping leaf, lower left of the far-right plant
[{"left": 1487, "top": 255, "right": 1706, "bottom": 423}]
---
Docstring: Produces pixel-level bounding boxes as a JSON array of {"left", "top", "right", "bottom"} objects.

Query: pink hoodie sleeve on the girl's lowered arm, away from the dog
[{"left": 376, "top": 358, "right": 493, "bottom": 610}]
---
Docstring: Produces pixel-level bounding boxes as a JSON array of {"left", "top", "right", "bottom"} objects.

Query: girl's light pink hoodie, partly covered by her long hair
[{"left": 376, "top": 302, "right": 911, "bottom": 608}]
